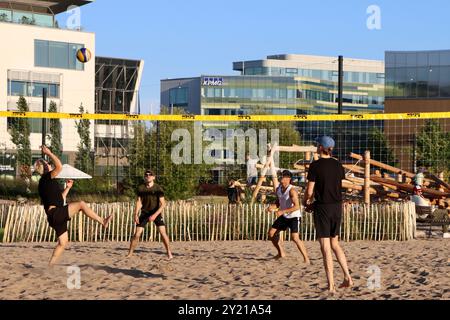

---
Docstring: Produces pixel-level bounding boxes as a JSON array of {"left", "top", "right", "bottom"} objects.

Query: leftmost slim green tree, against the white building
[{"left": 10, "top": 96, "right": 31, "bottom": 170}]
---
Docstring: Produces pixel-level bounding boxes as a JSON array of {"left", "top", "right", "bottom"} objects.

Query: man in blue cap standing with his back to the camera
[{"left": 303, "top": 136, "right": 353, "bottom": 293}]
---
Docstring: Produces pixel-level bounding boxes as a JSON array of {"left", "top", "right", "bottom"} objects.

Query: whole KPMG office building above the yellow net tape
[{"left": 161, "top": 55, "right": 384, "bottom": 115}]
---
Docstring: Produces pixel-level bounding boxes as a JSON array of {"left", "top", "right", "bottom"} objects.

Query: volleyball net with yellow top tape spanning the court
[{"left": 0, "top": 109, "right": 450, "bottom": 200}]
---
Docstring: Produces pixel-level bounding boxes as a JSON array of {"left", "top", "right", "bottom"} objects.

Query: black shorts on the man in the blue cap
[{"left": 314, "top": 203, "right": 342, "bottom": 238}]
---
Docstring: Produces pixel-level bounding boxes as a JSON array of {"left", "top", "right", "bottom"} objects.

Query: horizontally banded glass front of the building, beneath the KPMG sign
[{"left": 200, "top": 75, "right": 384, "bottom": 115}]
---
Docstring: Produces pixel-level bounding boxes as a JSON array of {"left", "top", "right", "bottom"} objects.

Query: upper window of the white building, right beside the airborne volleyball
[{"left": 34, "top": 40, "right": 84, "bottom": 70}]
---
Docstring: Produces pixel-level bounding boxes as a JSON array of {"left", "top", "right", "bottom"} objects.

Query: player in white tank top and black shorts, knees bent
[{"left": 269, "top": 163, "right": 310, "bottom": 264}]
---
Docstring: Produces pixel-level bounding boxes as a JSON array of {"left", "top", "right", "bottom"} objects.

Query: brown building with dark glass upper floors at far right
[{"left": 385, "top": 50, "right": 450, "bottom": 171}]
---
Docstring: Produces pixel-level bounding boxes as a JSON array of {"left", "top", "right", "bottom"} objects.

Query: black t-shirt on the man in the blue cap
[{"left": 308, "top": 158, "right": 345, "bottom": 204}]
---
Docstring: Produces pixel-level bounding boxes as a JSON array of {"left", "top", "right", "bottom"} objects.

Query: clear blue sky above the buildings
[{"left": 60, "top": 0, "right": 450, "bottom": 113}]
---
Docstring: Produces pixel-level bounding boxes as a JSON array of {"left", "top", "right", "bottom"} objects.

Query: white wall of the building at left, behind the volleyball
[{"left": 0, "top": 23, "right": 95, "bottom": 152}]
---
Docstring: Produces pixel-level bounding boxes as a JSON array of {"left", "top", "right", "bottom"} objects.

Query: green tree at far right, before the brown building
[{"left": 417, "top": 119, "right": 450, "bottom": 173}]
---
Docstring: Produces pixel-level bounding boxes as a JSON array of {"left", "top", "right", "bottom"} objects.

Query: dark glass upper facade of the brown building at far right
[{"left": 386, "top": 50, "right": 450, "bottom": 99}]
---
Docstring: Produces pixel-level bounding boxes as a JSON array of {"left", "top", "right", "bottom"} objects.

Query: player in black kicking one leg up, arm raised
[{"left": 34, "top": 146, "right": 112, "bottom": 265}]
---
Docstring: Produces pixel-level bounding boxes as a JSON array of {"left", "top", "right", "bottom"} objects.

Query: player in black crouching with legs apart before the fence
[{"left": 127, "top": 170, "right": 172, "bottom": 260}]
